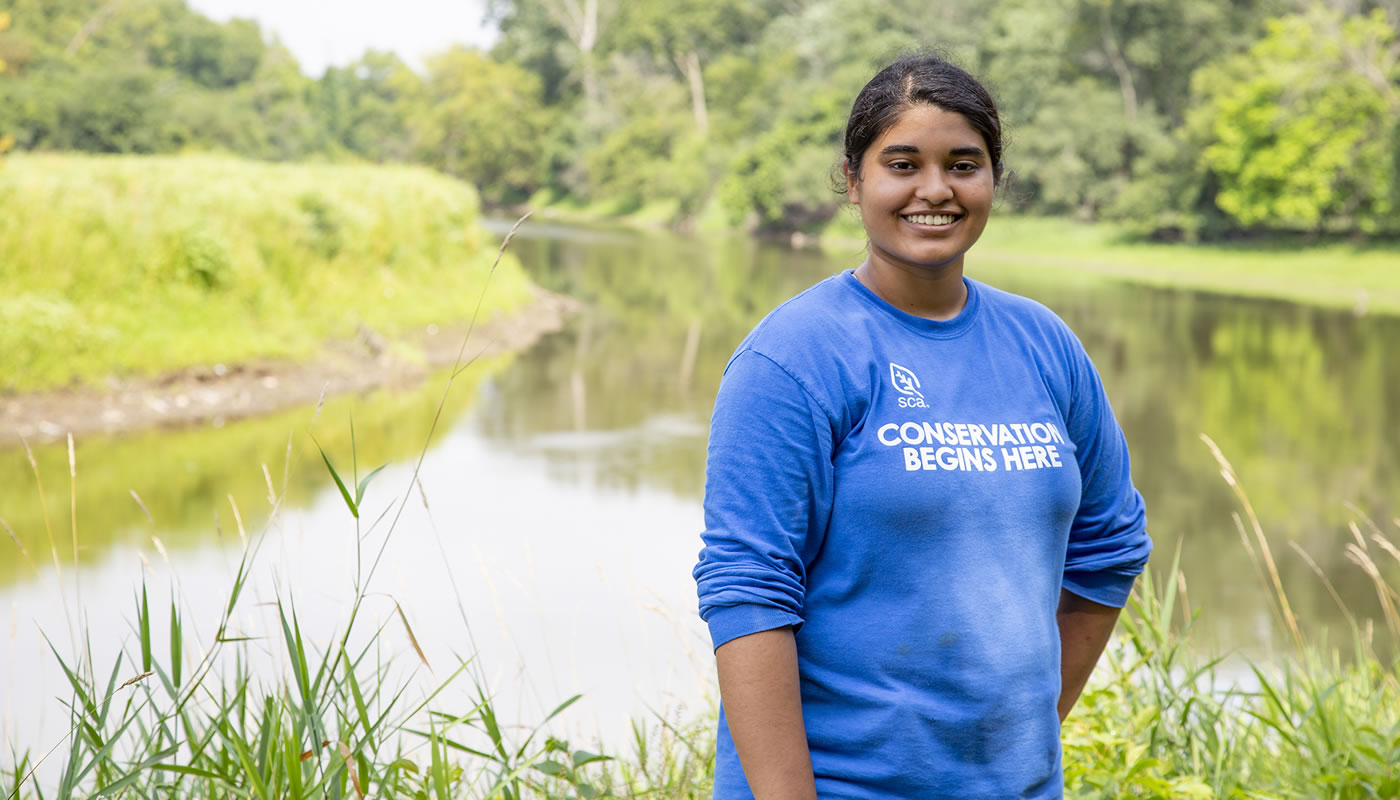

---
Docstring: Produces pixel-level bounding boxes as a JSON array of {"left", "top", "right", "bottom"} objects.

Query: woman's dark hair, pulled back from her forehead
[{"left": 841, "top": 53, "right": 1004, "bottom": 191}]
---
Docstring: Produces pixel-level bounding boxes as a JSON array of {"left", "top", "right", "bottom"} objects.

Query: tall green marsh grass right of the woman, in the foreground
[{"left": 1064, "top": 437, "right": 1400, "bottom": 800}]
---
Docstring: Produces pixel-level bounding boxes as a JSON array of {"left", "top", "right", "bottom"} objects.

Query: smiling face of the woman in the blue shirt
[{"left": 847, "top": 105, "right": 995, "bottom": 275}]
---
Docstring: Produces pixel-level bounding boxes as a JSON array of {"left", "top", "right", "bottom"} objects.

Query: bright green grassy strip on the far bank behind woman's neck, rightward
[{"left": 823, "top": 214, "right": 1400, "bottom": 314}]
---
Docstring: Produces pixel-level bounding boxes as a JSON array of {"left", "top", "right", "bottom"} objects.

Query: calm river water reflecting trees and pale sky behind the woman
[{"left": 0, "top": 226, "right": 1400, "bottom": 758}]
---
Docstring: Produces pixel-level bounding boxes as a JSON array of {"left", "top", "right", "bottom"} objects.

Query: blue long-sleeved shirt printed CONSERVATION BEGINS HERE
[{"left": 694, "top": 272, "right": 1152, "bottom": 800}]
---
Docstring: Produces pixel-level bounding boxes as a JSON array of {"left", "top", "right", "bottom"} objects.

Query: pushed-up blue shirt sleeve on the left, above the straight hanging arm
[{"left": 694, "top": 350, "right": 834, "bottom": 647}]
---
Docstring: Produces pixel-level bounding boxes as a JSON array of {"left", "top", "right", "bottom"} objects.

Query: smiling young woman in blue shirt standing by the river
[{"left": 694, "top": 56, "right": 1151, "bottom": 800}]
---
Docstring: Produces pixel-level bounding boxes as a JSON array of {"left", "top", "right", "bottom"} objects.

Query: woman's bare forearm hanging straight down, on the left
[{"left": 714, "top": 628, "right": 816, "bottom": 800}]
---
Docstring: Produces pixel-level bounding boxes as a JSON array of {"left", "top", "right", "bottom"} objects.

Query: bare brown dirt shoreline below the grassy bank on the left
[{"left": 0, "top": 289, "right": 578, "bottom": 447}]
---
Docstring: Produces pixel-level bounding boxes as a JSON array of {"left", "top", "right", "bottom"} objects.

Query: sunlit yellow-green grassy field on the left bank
[{"left": 0, "top": 154, "right": 529, "bottom": 392}]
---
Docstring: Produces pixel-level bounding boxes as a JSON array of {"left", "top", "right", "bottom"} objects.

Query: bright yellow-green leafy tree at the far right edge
[{"left": 1191, "top": 7, "right": 1400, "bottom": 234}]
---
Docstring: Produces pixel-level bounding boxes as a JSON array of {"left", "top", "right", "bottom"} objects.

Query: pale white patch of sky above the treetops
[{"left": 189, "top": 0, "right": 496, "bottom": 77}]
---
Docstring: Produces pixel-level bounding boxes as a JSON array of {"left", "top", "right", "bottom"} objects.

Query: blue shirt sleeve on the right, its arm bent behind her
[{"left": 1063, "top": 342, "right": 1152, "bottom": 608}]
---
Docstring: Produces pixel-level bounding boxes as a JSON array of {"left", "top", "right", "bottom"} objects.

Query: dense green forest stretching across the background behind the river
[{"left": 0, "top": 0, "right": 1400, "bottom": 240}]
